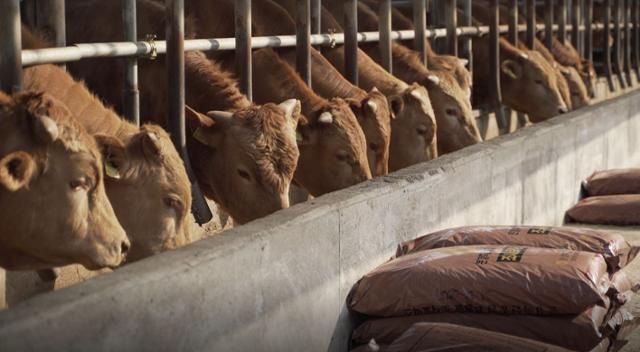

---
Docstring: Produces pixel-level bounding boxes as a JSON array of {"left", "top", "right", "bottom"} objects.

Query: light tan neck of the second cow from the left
[{"left": 24, "top": 65, "right": 138, "bottom": 143}]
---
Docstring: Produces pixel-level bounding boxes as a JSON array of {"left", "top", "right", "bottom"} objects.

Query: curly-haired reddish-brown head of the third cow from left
[{"left": 187, "top": 99, "right": 300, "bottom": 224}]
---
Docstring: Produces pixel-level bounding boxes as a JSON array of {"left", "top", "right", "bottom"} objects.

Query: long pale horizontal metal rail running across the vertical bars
[{"left": 22, "top": 24, "right": 604, "bottom": 66}]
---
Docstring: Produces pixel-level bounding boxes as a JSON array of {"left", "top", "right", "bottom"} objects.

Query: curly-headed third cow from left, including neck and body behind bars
[{"left": 66, "top": 0, "right": 298, "bottom": 223}]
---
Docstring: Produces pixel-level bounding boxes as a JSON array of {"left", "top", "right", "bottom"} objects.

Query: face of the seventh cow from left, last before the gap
[{"left": 424, "top": 71, "right": 482, "bottom": 154}]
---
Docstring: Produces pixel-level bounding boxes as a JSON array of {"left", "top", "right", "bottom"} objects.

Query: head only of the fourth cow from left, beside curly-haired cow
[{"left": 295, "top": 98, "right": 371, "bottom": 197}]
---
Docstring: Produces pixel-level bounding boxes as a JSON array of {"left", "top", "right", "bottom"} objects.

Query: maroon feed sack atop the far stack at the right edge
[{"left": 582, "top": 169, "right": 640, "bottom": 197}]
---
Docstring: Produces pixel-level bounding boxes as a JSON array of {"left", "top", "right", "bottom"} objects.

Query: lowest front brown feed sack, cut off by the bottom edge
[{"left": 384, "top": 323, "right": 570, "bottom": 352}]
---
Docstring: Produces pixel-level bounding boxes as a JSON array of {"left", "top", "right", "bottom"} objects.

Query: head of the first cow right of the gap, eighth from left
[{"left": 500, "top": 50, "right": 567, "bottom": 122}]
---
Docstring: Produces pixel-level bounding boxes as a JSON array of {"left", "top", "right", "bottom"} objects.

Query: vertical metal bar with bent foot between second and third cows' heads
[{"left": 165, "top": 0, "right": 213, "bottom": 225}]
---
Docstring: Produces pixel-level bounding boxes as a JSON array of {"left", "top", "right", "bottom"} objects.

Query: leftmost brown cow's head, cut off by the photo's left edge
[{"left": 0, "top": 92, "right": 130, "bottom": 270}]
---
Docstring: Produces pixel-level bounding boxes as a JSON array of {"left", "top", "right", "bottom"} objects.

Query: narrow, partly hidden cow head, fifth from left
[{"left": 349, "top": 88, "right": 391, "bottom": 176}]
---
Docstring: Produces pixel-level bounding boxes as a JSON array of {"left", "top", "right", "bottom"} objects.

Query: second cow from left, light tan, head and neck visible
[{"left": 23, "top": 29, "right": 191, "bottom": 262}]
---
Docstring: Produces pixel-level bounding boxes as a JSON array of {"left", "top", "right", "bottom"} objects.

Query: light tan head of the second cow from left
[{"left": 95, "top": 125, "right": 191, "bottom": 262}]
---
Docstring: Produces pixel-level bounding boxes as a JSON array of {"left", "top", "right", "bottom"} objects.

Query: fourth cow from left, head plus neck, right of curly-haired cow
[{"left": 253, "top": 49, "right": 371, "bottom": 196}]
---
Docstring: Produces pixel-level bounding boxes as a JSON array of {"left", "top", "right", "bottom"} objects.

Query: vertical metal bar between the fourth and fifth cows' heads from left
[{"left": 344, "top": 0, "right": 358, "bottom": 86}]
